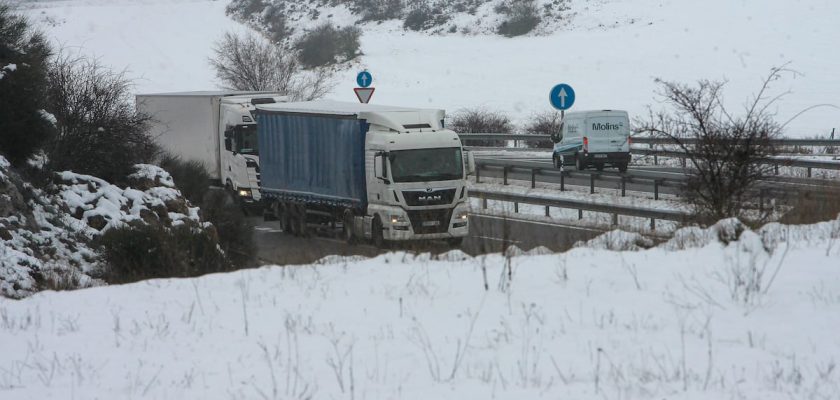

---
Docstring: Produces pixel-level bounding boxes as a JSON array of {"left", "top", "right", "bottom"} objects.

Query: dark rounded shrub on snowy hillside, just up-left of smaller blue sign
[{"left": 295, "top": 22, "right": 362, "bottom": 68}]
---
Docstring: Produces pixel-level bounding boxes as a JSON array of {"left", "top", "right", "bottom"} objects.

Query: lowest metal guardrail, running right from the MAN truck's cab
[{"left": 469, "top": 189, "right": 689, "bottom": 230}]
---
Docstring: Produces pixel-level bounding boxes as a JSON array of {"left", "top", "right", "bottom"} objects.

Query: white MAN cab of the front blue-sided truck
[{"left": 366, "top": 111, "right": 470, "bottom": 241}]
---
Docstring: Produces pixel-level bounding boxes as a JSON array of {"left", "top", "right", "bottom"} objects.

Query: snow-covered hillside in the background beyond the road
[{"left": 18, "top": 0, "right": 840, "bottom": 136}]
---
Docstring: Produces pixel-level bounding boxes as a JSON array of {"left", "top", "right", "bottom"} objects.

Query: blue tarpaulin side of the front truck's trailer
[{"left": 257, "top": 111, "right": 368, "bottom": 208}]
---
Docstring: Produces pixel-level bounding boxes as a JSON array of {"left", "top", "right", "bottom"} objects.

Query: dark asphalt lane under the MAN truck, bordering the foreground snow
[{"left": 252, "top": 215, "right": 602, "bottom": 265}]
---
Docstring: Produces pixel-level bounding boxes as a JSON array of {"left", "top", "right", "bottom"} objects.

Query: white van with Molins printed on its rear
[{"left": 551, "top": 110, "right": 630, "bottom": 172}]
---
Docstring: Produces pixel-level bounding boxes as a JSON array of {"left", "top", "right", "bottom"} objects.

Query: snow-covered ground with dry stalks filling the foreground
[{"left": 0, "top": 217, "right": 840, "bottom": 399}]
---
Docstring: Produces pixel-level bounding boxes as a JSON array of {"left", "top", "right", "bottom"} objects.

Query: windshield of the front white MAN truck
[{"left": 390, "top": 147, "right": 464, "bottom": 182}]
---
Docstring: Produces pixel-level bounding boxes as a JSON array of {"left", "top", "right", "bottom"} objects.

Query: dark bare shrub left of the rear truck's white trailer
[{"left": 45, "top": 53, "right": 157, "bottom": 183}]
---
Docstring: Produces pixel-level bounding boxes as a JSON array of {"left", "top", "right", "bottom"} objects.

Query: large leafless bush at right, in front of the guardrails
[{"left": 636, "top": 67, "right": 792, "bottom": 224}]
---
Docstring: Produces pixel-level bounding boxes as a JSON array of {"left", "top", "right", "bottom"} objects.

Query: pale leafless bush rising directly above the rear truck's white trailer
[{"left": 210, "top": 32, "right": 332, "bottom": 101}]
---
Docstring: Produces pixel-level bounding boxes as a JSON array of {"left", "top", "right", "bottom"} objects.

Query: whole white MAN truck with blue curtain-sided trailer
[{"left": 256, "top": 101, "right": 474, "bottom": 246}]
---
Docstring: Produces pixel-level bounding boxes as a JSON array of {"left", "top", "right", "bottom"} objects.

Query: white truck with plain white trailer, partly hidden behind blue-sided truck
[{"left": 136, "top": 91, "right": 286, "bottom": 203}]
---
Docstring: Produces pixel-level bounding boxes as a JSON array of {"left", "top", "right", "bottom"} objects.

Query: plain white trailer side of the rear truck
[{"left": 137, "top": 95, "right": 222, "bottom": 179}]
